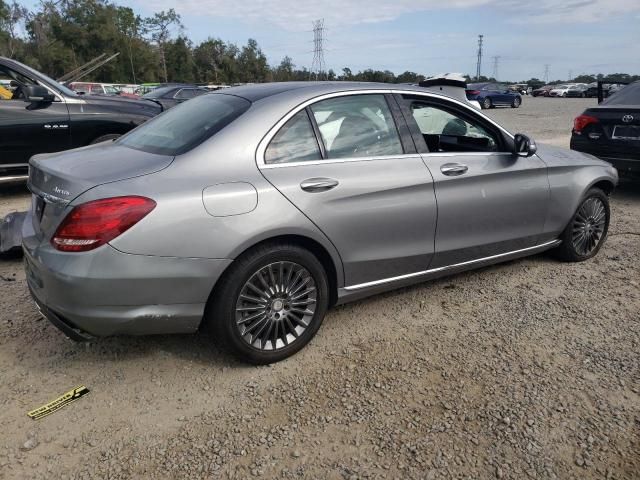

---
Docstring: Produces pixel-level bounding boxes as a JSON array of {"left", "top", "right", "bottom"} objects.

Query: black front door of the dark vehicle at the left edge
[{"left": 0, "top": 65, "right": 70, "bottom": 169}]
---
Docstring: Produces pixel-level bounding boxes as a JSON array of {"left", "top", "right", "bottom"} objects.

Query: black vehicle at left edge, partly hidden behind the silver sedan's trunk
[{"left": 0, "top": 57, "right": 162, "bottom": 182}]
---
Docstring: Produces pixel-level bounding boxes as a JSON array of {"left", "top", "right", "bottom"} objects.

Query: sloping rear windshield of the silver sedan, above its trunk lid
[{"left": 117, "top": 93, "right": 251, "bottom": 156}]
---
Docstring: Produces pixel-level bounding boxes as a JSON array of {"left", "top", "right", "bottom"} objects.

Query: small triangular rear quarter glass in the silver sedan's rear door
[{"left": 264, "top": 110, "right": 322, "bottom": 163}]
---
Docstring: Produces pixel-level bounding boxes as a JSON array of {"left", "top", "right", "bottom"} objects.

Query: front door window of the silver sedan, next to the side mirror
[{"left": 411, "top": 102, "right": 499, "bottom": 152}]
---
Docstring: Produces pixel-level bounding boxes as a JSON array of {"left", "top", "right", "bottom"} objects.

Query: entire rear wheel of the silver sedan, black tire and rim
[{"left": 205, "top": 242, "right": 329, "bottom": 365}]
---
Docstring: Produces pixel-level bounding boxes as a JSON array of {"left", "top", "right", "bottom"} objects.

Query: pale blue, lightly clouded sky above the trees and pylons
[{"left": 17, "top": 0, "right": 640, "bottom": 81}]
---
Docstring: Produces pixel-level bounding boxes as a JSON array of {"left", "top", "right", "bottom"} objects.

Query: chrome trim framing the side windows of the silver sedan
[{"left": 256, "top": 88, "right": 514, "bottom": 169}]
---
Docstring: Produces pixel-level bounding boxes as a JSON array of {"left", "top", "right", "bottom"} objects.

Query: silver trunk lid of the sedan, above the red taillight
[{"left": 28, "top": 142, "right": 174, "bottom": 203}]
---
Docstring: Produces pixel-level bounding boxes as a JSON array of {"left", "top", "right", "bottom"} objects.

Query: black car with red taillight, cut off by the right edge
[{"left": 571, "top": 82, "right": 640, "bottom": 177}]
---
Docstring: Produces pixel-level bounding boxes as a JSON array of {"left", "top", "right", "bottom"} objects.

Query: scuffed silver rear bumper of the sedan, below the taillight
[{"left": 23, "top": 218, "right": 231, "bottom": 340}]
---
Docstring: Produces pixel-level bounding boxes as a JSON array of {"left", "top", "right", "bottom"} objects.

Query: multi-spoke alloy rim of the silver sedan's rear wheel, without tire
[{"left": 236, "top": 262, "right": 317, "bottom": 350}]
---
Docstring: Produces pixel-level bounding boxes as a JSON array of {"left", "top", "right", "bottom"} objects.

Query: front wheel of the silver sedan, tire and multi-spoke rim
[{"left": 555, "top": 188, "right": 611, "bottom": 262}]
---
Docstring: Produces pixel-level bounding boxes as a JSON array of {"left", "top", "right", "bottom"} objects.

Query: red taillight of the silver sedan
[{"left": 51, "top": 196, "right": 156, "bottom": 252}]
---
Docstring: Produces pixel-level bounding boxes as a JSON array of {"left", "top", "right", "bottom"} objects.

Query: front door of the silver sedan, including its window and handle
[{"left": 399, "top": 95, "right": 549, "bottom": 268}]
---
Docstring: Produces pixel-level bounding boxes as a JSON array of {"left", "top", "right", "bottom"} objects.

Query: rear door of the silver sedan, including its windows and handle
[{"left": 258, "top": 93, "right": 437, "bottom": 286}]
